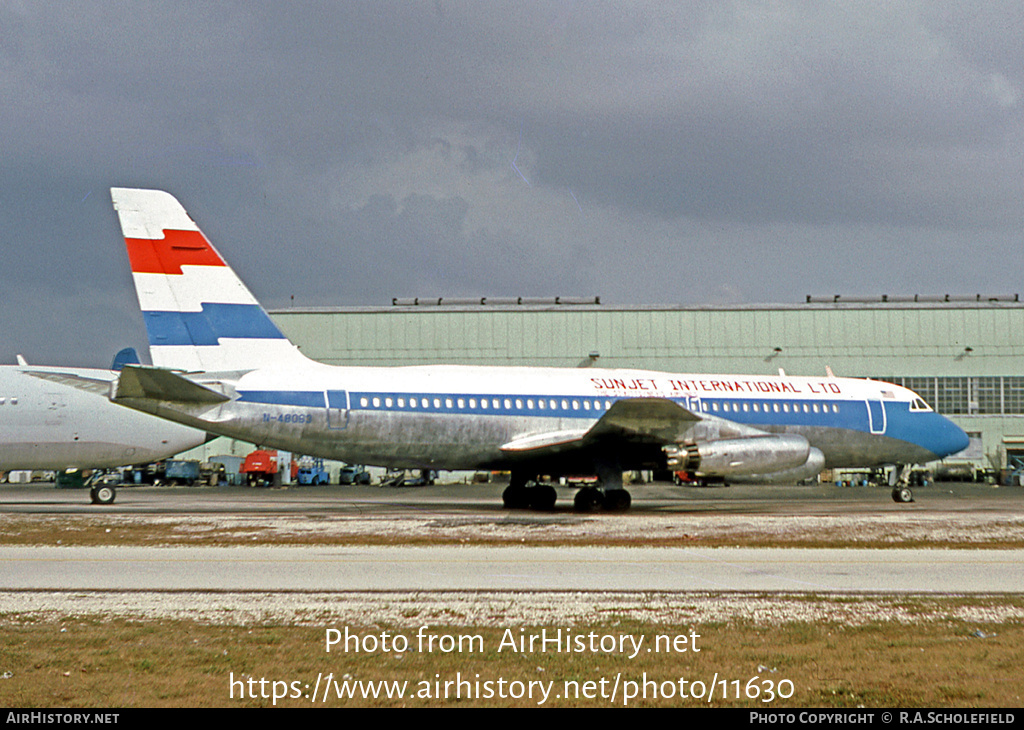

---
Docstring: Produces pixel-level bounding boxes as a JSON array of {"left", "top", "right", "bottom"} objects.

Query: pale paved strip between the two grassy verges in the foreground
[{"left": 0, "top": 546, "right": 1024, "bottom": 594}]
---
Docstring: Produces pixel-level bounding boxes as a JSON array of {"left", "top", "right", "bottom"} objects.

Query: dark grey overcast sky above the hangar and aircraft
[{"left": 0, "top": 0, "right": 1024, "bottom": 367}]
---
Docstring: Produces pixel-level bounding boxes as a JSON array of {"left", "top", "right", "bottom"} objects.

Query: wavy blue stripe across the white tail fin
[{"left": 142, "top": 303, "right": 285, "bottom": 346}]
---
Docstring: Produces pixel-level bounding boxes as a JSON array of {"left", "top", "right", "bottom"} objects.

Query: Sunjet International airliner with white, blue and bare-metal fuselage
[{"left": 97, "top": 188, "right": 968, "bottom": 510}]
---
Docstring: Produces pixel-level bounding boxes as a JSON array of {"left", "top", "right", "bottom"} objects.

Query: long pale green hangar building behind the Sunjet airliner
[{"left": 270, "top": 295, "right": 1024, "bottom": 469}]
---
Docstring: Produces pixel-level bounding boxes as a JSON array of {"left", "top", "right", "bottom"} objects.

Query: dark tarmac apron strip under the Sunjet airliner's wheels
[{"left": 0, "top": 483, "right": 1024, "bottom": 516}]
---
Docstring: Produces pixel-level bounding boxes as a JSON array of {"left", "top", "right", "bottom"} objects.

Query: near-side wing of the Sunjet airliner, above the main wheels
[{"left": 501, "top": 398, "right": 701, "bottom": 456}]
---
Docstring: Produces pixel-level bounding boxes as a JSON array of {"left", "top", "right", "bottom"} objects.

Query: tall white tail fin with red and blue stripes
[{"left": 111, "top": 187, "right": 306, "bottom": 371}]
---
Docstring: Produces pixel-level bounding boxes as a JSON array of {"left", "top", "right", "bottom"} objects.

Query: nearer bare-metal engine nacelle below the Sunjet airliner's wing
[{"left": 664, "top": 434, "right": 824, "bottom": 477}]
